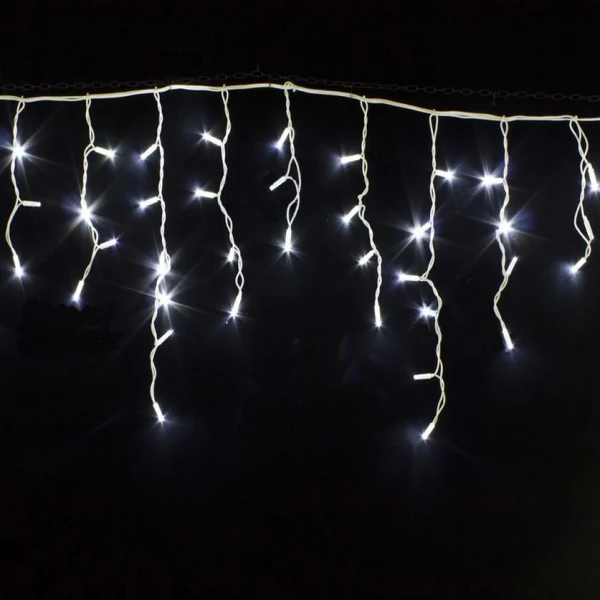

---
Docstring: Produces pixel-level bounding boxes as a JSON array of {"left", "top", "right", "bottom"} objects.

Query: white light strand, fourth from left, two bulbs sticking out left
[{"left": 196, "top": 86, "right": 244, "bottom": 319}]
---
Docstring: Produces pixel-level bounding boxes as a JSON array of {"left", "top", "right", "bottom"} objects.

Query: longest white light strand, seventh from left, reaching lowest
[{"left": 399, "top": 114, "right": 446, "bottom": 440}]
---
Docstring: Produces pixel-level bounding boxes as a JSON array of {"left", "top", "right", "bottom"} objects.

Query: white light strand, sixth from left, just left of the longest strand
[{"left": 340, "top": 98, "right": 383, "bottom": 327}]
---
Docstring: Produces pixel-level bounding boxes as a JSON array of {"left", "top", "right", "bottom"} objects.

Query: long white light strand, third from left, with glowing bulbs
[{"left": 140, "top": 91, "right": 173, "bottom": 423}]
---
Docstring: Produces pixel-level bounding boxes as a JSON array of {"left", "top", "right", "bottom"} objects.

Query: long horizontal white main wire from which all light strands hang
[{"left": 5, "top": 82, "right": 600, "bottom": 122}]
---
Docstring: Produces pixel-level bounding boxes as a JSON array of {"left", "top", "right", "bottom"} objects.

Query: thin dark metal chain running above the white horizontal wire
[{"left": 0, "top": 68, "right": 600, "bottom": 103}]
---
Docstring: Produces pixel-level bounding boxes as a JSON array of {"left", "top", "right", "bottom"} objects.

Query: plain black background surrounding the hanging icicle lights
[{"left": 0, "top": 1, "right": 600, "bottom": 598}]
